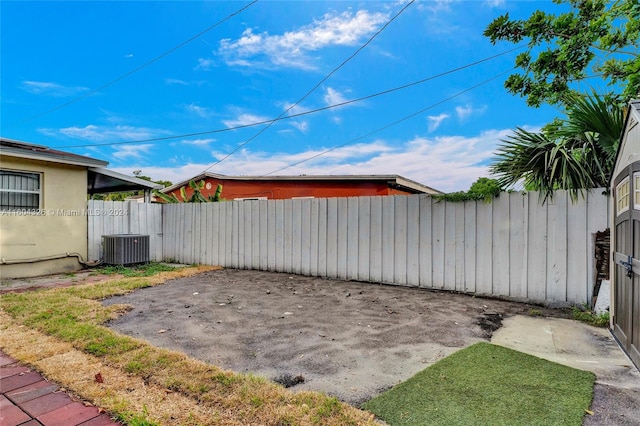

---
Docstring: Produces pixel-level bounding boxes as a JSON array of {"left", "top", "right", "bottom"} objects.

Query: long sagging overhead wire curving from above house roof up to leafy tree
[{"left": 54, "top": 45, "right": 526, "bottom": 148}]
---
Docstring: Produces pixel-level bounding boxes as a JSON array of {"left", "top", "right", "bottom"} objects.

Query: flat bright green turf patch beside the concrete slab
[{"left": 363, "top": 342, "right": 595, "bottom": 426}]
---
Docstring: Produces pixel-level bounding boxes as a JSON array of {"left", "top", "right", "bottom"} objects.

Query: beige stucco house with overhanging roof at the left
[{"left": 0, "top": 138, "right": 161, "bottom": 279}]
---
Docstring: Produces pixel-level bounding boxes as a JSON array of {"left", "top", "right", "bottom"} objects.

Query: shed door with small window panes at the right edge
[{"left": 613, "top": 162, "right": 640, "bottom": 367}]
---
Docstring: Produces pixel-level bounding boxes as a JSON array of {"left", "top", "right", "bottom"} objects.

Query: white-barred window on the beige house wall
[{"left": 0, "top": 169, "right": 41, "bottom": 211}]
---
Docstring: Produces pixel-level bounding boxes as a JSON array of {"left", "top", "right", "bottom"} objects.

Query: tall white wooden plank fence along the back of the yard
[{"left": 89, "top": 190, "right": 608, "bottom": 304}]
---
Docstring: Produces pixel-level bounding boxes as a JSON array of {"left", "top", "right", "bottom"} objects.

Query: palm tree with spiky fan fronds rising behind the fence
[{"left": 490, "top": 93, "right": 624, "bottom": 202}]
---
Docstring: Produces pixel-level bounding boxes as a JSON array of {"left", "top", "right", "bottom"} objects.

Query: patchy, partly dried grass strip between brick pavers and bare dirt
[{"left": 0, "top": 267, "right": 375, "bottom": 425}]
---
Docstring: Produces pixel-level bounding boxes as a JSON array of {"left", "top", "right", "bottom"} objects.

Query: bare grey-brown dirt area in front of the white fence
[{"left": 104, "top": 269, "right": 567, "bottom": 406}]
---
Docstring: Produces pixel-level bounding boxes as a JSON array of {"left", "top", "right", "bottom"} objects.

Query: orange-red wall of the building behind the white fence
[{"left": 166, "top": 178, "right": 411, "bottom": 201}]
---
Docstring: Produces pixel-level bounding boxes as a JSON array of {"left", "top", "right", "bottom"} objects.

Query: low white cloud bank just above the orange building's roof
[{"left": 124, "top": 130, "right": 511, "bottom": 192}]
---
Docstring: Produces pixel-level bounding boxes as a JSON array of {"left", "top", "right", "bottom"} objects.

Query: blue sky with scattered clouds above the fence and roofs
[{"left": 0, "top": 0, "right": 560, "bottom": 191}]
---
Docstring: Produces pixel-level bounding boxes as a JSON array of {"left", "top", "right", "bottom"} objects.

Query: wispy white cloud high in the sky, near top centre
[{"left": 218, "top": 10, "right": 388, "bottom": 69}]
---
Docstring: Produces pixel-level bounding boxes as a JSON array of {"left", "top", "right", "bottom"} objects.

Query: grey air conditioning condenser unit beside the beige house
[{"left": 102, "top": 234, "right": 149, "bottom": 265}]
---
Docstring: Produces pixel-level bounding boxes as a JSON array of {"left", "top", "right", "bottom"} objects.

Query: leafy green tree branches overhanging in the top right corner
[{"left": 484, "top": 0, "right": 640, "bottom": 107}]
